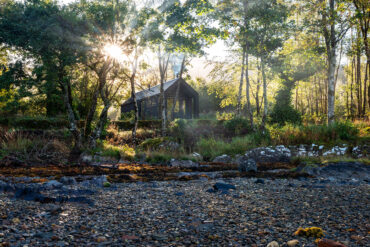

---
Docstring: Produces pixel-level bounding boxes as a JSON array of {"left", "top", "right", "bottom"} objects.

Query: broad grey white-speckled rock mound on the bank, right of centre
[{"left": 244, "top": 146, "right": 290, "bottom": 163}]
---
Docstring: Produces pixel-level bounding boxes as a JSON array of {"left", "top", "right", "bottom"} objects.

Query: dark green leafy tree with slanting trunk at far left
[{"left": 0, "top": 1, "right": 88, "bottom": 153}]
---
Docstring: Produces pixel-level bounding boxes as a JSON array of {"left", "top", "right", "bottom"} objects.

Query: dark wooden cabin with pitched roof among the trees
[{"left": 121, "top": 78, "right": 199, "bottom": 120}]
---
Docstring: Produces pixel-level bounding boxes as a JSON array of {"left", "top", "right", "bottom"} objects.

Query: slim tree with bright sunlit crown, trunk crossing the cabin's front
[{"left": 150, "top": 0, "right": 218, "bottom": 136}]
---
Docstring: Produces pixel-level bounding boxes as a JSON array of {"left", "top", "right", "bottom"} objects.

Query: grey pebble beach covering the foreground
[{"left": 0, "top": 178, "right": 370, "bottom": 247}]
